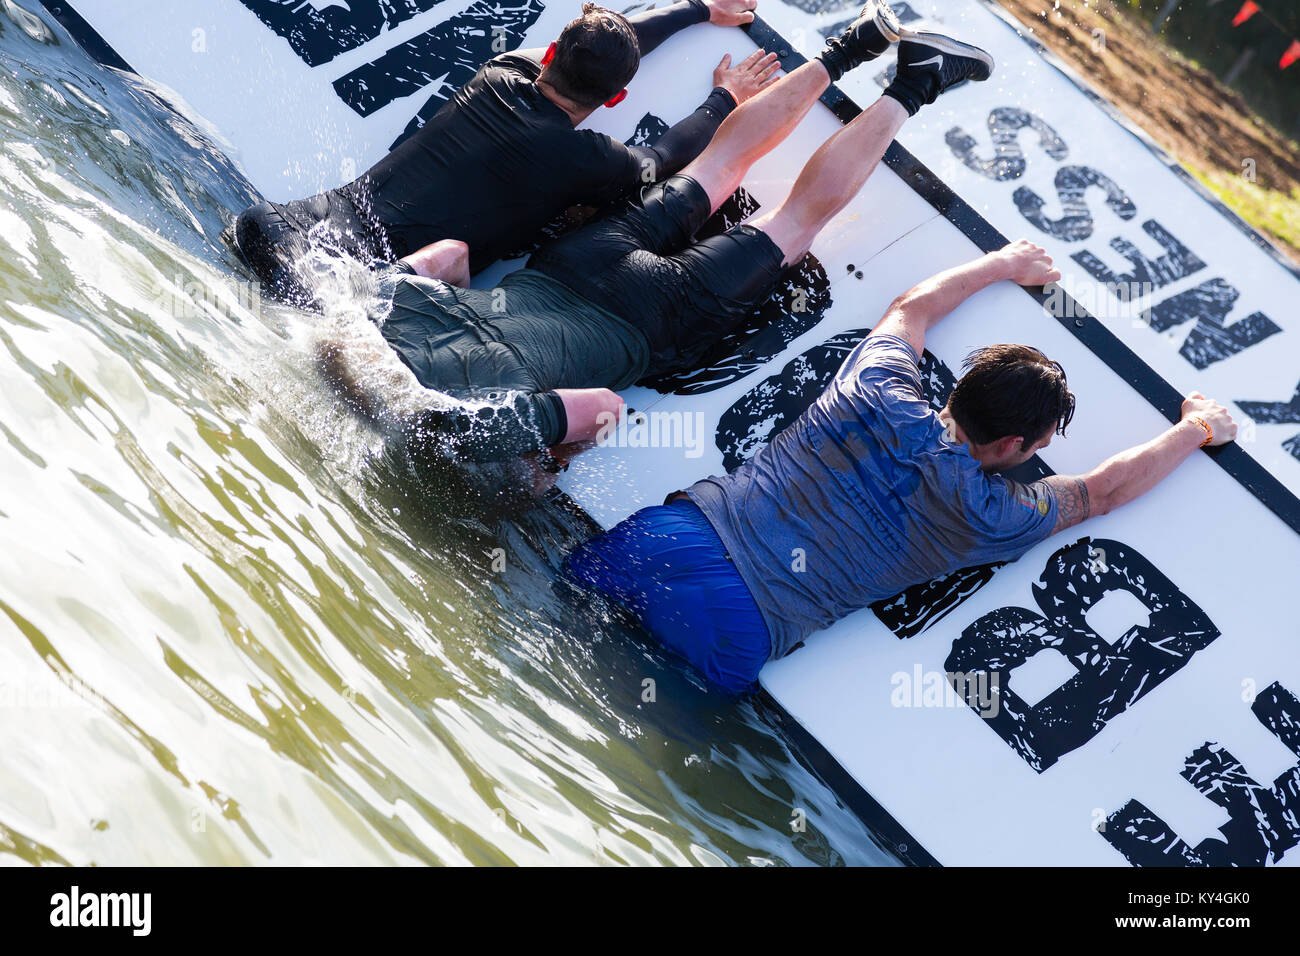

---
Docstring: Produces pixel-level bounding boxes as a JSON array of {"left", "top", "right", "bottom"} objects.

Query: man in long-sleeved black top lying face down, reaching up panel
[{"left": 234, "top": 0, "right": 777, "bottom": 306}]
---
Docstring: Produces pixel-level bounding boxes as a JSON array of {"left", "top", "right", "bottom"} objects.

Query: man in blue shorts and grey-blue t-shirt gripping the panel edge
[{"left": 566, "top": 239, "right": 1236, "bottom": 693}]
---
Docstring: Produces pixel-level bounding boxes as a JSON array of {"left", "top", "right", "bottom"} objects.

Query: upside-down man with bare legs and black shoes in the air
[{"left": 322, "top": 0, "right": 993, "bottom": 478}]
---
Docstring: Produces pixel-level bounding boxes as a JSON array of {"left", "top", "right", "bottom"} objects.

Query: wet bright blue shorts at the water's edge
[{"left": 564, "top": 498, "right": 772, "bottom": 693}]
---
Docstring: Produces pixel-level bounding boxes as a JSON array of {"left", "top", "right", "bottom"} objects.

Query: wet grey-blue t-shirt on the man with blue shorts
[{"left": 686, "top": 334, "right": 1057, "bottom": 657}]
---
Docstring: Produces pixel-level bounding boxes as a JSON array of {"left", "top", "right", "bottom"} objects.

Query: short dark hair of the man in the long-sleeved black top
[{"left": 546, "top": 3, "right": 641, "bottom": 109}]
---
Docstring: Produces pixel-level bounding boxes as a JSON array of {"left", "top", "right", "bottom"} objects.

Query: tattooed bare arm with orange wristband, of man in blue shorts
[{"left": 1035, "top": 392, "right": 1236, "bottom": 533}]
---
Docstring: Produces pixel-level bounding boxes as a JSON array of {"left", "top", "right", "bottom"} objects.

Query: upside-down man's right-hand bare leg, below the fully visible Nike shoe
[{"left": 748, "top": 96, "right": 907, "bottom": 265}]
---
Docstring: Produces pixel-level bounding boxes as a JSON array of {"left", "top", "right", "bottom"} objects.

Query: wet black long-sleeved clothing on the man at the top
[{"left": 237, "top": 0, "right": 735, "bottom": 298}]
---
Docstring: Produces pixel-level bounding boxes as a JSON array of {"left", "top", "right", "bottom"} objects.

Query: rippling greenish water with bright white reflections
[{"left": 0, "top": 3, "right": 891, "bottom": 864}]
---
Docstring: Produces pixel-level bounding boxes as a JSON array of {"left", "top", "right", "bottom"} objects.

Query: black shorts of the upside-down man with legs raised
[{"left": 528, "top": 176, "right": 784, "bottom": 376}]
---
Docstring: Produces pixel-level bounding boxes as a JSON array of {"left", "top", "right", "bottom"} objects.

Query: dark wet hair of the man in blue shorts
[{"left": 948, "top": 345, "right": 1074, "bottom": 450}]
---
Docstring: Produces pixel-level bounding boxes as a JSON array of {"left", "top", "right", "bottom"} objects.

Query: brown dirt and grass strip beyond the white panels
[{"left": 998, "top": 0, "right": 1300, "bottom": 263}]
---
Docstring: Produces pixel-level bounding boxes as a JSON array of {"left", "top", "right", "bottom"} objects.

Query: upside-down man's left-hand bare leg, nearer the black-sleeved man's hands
[{"left": 681, "top": 60, "right": 831, "bottom": 211}]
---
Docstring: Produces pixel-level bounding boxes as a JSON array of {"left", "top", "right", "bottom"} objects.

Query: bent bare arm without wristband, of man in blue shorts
[{"left": 872, "top": 239, "right": 1061, "bottom": 355}]
